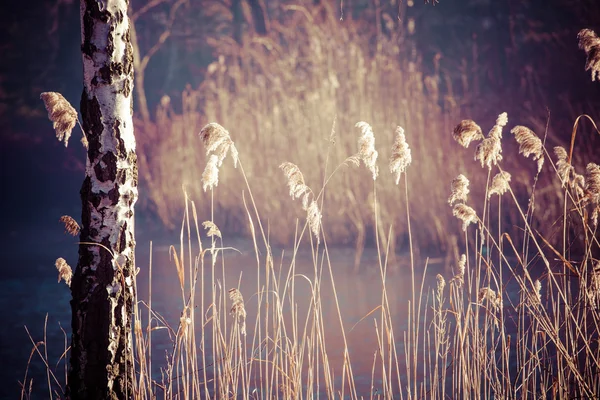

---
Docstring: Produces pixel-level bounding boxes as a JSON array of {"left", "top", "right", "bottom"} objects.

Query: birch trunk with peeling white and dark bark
[{"left": 67, "top": 0, "right": 138, "bottom": 400}]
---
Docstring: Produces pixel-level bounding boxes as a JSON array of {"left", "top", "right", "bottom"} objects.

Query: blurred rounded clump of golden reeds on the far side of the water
[{"left": 136, "top": 1, "right": 524, "bottom": 263}]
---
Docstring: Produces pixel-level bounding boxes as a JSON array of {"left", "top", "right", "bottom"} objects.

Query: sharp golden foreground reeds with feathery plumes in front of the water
[{"left": 23, "top": 106, "right": 600, "bottom": 399}]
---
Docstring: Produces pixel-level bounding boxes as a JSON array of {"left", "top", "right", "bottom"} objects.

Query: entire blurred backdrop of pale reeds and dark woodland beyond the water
[{"left": 0, "top": 0, "right": 600, "bottom": 262}]
